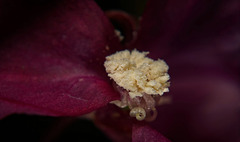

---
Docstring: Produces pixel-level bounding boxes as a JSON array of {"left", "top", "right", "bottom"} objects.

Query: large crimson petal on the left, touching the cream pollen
[{"left": 0, "top": 0, "right": 119, "bottom": 117}]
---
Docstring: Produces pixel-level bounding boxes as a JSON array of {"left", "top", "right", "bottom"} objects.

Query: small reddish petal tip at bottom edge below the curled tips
[{"left": 132, "top": 124, "right": 170, "bottom": 142}]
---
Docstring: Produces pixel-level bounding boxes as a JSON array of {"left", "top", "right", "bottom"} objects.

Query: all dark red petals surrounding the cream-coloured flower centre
[{"left": 0, "top": 0, "right": 240, "bottom": 142}]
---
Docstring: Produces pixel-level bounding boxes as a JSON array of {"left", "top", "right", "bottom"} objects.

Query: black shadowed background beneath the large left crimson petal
[{"left": 0, "top": 114, "right": 110, "bottom": 142}]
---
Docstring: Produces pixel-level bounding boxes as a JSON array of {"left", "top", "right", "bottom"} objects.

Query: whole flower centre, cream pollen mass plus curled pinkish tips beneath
[{"left": 104, "top": 50, "right": 170, "bottom": 121}]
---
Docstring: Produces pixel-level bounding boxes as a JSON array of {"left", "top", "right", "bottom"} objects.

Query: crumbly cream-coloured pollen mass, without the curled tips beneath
[{"left": 104, "top": 50, "right": 170, "bottom": 98}]
